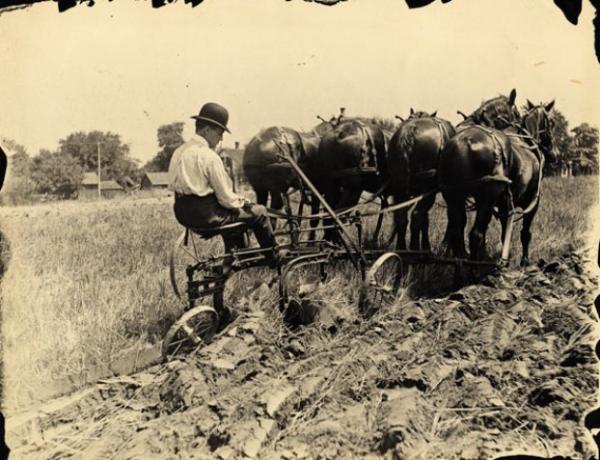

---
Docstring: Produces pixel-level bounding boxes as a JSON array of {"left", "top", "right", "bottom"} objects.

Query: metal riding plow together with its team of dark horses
[{"left": 163, "top": 90, "right": 554, "bottom": 357}]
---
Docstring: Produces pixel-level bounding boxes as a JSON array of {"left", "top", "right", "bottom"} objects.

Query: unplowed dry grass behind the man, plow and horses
[{"left": 0, "top": 177, "right": 598, "bottom": 409}]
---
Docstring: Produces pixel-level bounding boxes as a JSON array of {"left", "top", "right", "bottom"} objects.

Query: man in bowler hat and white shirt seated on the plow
[{"left": 169, "top": 102, "right": 276, "bottom": 266}]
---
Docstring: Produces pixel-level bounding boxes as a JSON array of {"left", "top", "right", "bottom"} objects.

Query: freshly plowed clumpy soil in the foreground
[{"left": 7, "top": 253, "right": 598, "bottom": 459}]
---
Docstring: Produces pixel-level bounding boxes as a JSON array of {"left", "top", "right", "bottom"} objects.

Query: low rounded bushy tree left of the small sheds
[{"left": 31, "top": 149, "right": 83, "bottom": 199}]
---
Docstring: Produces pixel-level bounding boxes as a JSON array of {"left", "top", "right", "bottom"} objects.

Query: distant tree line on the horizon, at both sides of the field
[{"left": 0, "top": 109, "right": 599, "bottom": 204}]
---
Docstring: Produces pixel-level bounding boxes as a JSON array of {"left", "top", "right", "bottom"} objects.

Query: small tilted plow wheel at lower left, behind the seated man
[{"left": 162, "top": 305, "right": 219, "bottom": 360}]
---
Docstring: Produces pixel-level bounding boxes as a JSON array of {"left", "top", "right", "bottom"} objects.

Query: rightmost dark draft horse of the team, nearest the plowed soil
[{"left": 439, "top": 101, "right": 556, "bottom": 265}]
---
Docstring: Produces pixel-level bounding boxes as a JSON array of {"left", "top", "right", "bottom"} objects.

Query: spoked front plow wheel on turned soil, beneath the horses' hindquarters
[{"left": 358, "top": 252, "right": 402, "bottom": 318}]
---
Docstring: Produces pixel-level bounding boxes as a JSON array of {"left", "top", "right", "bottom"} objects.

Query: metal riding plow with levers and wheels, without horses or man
[{"left": 162, "top": 153, "right": 511, "bottom": 359}]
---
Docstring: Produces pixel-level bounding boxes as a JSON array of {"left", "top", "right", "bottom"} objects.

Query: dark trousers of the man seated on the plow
[{"left": 173, "top": 193, "right": 275, "bottom": 249}]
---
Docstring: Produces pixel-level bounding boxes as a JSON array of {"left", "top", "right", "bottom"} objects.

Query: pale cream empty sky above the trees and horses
[{"left": 0, "top": 0, "right": 600, "bottom": 164}]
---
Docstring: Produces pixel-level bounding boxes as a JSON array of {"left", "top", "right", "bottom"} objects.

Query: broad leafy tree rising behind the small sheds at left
[{"left": 58, "top": 131, "right": 139, "bottom": 183}]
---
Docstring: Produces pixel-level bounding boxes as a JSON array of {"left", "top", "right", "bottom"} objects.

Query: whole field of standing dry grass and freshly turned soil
[{"left": 0, "top": 177, "right": 598, "bottom": 458}]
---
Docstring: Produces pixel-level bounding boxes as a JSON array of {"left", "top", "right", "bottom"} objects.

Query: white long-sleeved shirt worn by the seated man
[{"left": 169, "top": 134, "right": 246, "bottom": 208}]
